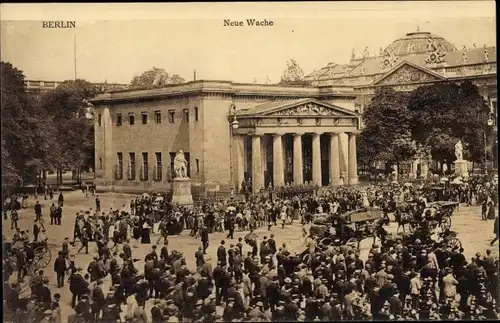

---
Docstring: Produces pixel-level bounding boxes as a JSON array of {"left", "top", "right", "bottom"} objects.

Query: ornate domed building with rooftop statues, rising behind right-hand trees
[{"left": 305, "top": 31, "right": 498, "bottom": 175}]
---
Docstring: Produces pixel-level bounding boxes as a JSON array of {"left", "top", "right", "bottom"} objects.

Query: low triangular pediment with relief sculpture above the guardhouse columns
[{"left": 242, "top": 98, "right": 359, "bottom": 117}]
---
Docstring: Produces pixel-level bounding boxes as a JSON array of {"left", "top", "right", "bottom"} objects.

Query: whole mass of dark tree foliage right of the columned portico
[{"left": 358, "top": 81, "right": 489, "bottom": 170}]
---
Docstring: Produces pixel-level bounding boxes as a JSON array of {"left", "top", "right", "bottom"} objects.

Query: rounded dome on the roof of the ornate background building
[{"left": 385, "top": 31, "right": 457, "bottom": 56}]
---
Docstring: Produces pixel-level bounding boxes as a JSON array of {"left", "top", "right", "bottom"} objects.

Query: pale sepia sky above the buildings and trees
[{"left": 0, "top": 1, "right": 496, "bottom": 84}]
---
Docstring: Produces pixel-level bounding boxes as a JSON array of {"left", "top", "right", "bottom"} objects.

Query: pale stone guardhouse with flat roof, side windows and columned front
[{"left": 92, "top": 81, "right": 359, "bottom": 192}]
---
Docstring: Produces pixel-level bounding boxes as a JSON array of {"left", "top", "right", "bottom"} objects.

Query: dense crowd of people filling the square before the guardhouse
[{"left": 4, "top": 178, "right": 499, "bottom": 323}]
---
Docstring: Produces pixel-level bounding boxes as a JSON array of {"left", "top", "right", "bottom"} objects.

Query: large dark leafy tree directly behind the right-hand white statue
[{"left": 408, "top": 81, "right": 489, "bottom": 163}]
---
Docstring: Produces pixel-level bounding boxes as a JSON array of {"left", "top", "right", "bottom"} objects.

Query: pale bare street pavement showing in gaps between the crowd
[{"left": 3, "top": 191, "right": 498, "bottom": 318}]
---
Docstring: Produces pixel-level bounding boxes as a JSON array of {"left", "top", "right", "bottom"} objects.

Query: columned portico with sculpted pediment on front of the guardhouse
[{"left": 235, "top": 99, "right": 359, "bottom": 193}]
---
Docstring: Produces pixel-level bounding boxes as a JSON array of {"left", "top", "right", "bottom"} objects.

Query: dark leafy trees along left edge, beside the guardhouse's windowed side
[{"left": 1, "top": 62, "right": 97, "bottom": 186}]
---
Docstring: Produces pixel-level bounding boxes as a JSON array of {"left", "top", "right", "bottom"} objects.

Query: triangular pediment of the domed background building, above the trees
[{"left": 373, "top": 61, "right": 445, "bottom": 85}]
